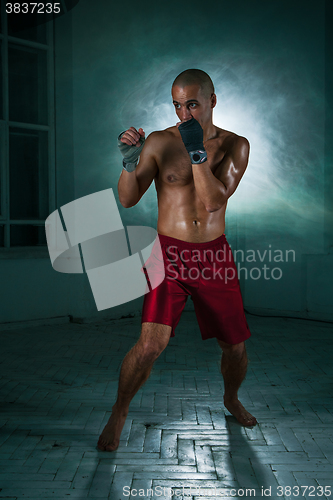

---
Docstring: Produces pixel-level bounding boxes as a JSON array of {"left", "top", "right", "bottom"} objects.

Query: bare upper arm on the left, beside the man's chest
[{"left": 135, "top": 132, "right": 158, "bottom": 198}]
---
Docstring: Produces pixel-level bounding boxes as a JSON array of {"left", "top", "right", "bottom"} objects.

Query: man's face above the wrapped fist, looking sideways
[{"left": 172, "top": 85, "right": 215, "bottom": 126}]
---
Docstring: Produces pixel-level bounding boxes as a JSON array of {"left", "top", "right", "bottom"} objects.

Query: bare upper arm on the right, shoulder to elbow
[{"left": 214, "top": 137, "right": 250, "bottom": 198}]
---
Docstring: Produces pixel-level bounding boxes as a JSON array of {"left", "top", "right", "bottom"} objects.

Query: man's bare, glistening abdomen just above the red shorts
[{"left": 157, "top": 182, "right": 227, "bottom": 243}]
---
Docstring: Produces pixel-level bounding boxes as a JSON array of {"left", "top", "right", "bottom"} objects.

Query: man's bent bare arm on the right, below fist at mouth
[{"left": 192, "top": 136, "right": 250, "bottom": 212}]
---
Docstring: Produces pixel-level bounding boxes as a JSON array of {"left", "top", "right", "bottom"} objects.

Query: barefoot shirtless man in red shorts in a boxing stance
[{"left": 98, "top": 69, "right": 256, "bottom": 451}]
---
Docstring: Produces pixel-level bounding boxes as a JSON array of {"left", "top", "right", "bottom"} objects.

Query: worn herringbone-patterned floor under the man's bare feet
[{"left": 0, "top": 312, "right": 333, "bottom": 500}]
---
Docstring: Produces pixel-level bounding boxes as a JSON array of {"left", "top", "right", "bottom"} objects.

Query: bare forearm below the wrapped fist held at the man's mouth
[{"left": 192, "top": 160, "right": 228, "bottom": 212}]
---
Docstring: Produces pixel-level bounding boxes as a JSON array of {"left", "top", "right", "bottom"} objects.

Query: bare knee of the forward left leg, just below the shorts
[{"left": 137, "top": 323, "right": 171, "bottom": 363}]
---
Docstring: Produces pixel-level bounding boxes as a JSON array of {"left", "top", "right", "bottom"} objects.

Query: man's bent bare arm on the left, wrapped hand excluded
[{"left": 118, "top": 132, "right": 158, "bottom": 208}]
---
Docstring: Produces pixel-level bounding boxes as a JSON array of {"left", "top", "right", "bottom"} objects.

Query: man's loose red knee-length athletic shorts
[{"left": 141, "top": 234, "right": 251, "bottom": 344}]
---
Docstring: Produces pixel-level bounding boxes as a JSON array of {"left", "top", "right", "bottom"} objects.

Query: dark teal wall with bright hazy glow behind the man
[{"left": 0, "top": 0, "right": 333, "bottom": 328}]
